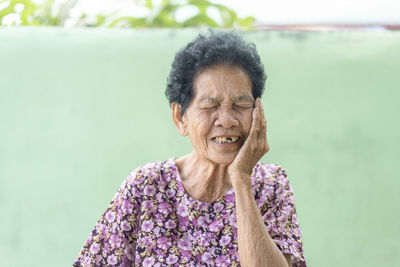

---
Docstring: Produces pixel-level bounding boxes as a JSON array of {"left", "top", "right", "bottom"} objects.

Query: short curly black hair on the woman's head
[{"left": 165, "top": 31, "right": 267, "bottom": 116}]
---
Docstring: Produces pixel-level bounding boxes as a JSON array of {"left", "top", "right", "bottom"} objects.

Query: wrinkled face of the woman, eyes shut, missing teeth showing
[{"left": 183, "top": 65, "right": 254, "bottom": 164}]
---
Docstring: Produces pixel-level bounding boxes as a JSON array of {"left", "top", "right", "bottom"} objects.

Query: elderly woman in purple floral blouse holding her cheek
[{"left": 74, "top": 32, "right": 306, "bottom": 267}]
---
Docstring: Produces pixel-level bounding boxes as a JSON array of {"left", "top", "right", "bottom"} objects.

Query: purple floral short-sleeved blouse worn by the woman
[{"left": 73, "top": 159, "right": 306, "bottom": 267}]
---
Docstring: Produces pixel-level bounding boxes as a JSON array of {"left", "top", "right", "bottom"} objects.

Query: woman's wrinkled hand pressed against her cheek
[{"left": 228, "top": 98, "right": 269, "bottom": 186}]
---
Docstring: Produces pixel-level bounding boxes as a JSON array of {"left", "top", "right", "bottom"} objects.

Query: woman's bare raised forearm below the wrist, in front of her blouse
[{"left": 234, "top": 178, "right": 288, "bottom": 267}]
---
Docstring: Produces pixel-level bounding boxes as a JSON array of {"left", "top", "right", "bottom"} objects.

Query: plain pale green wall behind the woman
[{"left": 0, "top": 28, "right": 400, "bottom": 267}]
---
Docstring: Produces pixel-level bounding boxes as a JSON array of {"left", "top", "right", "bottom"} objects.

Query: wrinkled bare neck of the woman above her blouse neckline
[{"left": 176, "top": 151, "right": 232, "bottom": 203}]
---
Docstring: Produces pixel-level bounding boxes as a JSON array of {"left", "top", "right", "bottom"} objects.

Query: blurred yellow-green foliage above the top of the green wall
[{"left": 0, "top": 0, "right": 255, "bottom": 29}]
